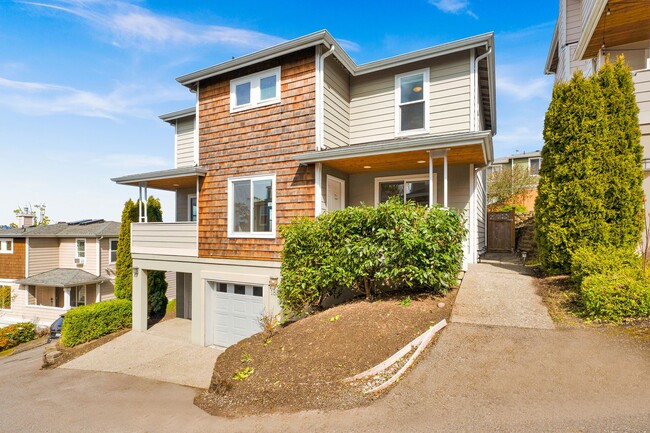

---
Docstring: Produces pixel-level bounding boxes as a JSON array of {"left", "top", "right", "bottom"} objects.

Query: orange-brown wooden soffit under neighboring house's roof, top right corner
[{"left": 582, "top": 0, "right": 650, "bottom": 59}]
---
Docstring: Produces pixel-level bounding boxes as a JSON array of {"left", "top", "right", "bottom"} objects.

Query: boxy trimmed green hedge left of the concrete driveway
[{"left": 61, "top": 299, "right": 131, "bottom": 347}]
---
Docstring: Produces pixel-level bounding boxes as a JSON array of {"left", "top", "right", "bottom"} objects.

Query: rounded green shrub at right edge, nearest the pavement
[{"left": 580, "top": 268, "right": 650, "bottom": 322}]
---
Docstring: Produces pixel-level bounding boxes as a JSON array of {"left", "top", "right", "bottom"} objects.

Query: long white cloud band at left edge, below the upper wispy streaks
[{"left": 0, "top": 77, "right": 187, "bottom": 120}]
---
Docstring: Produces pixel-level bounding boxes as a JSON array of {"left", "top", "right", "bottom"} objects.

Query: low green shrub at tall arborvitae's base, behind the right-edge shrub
[{"left": 571, "top": 245, "right": 641, "bottom": 285}]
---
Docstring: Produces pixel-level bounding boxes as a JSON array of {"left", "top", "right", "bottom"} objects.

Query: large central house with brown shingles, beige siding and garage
[{"left": 113, "top": 31, "right": 496, "bottom": 346}]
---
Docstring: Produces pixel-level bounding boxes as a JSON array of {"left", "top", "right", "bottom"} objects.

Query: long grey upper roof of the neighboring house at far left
[{"left": 0, "top": 220, "right": 120, "bottom": 238}]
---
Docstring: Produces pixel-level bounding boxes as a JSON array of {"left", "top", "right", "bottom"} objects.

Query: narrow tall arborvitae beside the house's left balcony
[{"left": 114, "top": 199, "right": 138, "bottom": 300}]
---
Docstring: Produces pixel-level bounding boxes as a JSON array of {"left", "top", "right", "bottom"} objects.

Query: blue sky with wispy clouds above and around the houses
[{"left": 0, "top": 0, "right": 558, "bottom": 224}]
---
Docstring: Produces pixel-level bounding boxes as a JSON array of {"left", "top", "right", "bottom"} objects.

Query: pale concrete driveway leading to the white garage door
[{"left": 59, "top": 319, "right": 223, "bottom": 388}]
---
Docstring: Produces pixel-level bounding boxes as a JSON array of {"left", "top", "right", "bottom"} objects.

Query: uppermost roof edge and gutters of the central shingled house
[{"left": 175, "top": 30, "right": 496, "bottom": 134}]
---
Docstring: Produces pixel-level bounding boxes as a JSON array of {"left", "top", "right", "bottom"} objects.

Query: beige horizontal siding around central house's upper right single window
[{"left": 350, "top": 52, "right": 471, "bottom": 144}]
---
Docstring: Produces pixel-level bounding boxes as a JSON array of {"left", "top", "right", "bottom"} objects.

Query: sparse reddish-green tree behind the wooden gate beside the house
[{"left": 487, "top": 165, "right": 538, "bottom": 208}]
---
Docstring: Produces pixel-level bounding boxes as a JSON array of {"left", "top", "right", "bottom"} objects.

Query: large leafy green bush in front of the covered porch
[{"left": 278, "top": 199, "right": 466, "bottom": 314}]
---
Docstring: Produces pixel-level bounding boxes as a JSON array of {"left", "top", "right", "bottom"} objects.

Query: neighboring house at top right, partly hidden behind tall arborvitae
[{"left": 545, "top": 0, "right": 650, "bottom": 197}]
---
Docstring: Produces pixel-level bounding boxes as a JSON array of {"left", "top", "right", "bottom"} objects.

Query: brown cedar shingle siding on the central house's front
[{"left": 199, "top": 48, "right": 315, "bottom": 260}]
